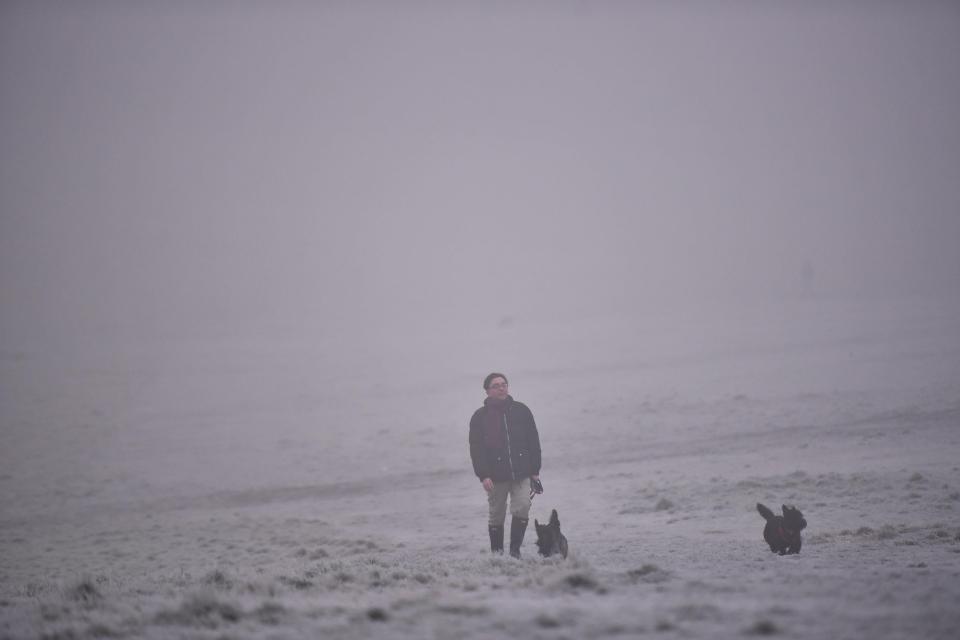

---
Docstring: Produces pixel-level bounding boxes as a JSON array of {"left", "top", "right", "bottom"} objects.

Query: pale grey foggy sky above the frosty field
[{"left": 0, "top": 2, "right": 960, "bottom": 349}]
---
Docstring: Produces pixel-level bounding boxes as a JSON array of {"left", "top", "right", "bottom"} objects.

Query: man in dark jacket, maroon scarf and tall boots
[{"left": 470, "top": 373, "right": 540, "bottom": 558}]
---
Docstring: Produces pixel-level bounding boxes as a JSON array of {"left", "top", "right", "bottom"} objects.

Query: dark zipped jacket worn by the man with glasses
[{"left": 470, "top": 396, "right": 540, "bottom": 482}]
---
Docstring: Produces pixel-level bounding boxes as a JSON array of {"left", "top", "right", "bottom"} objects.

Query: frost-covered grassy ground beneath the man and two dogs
[{"left": 0, "top": 301, "right": 960, "bottom": 639}]
